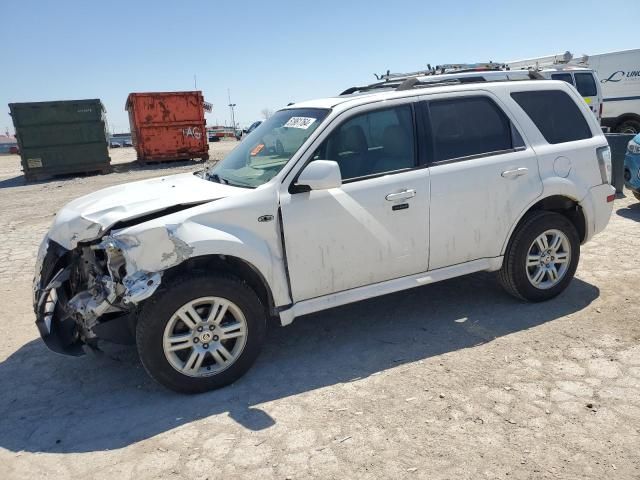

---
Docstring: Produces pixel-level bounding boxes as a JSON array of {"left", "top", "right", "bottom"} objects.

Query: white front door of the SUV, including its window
[{"left": 281, "top": 104, "right": 429, "bottom": 302}]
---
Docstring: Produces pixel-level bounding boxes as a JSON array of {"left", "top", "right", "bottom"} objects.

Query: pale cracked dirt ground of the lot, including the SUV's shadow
[{"left": 0, "top": 142, "right": 640, "bottom": 480}]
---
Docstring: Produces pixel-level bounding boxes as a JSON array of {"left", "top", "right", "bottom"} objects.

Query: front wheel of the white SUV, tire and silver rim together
[{"left": 136, "top": 274, "right": 266, "bottom": 393}]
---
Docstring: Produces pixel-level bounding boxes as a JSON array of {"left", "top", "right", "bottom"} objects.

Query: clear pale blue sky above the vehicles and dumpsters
[{"left": 0, "top": 0, "right": 640, "bottom": 133}]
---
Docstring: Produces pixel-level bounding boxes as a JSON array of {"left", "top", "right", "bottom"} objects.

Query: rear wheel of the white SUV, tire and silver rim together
[{"left": 498, "top": 211, "right": 580, "bottom": 302}]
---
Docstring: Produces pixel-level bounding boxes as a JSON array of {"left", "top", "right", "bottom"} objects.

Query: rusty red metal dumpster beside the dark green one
[{"left": 125, "top": 91, "right": 209, "bottom": 163}]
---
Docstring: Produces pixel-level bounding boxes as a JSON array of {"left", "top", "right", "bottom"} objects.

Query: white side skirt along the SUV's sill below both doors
[{"left": 280, "top": 257, "right": 503, "bottom": 326}]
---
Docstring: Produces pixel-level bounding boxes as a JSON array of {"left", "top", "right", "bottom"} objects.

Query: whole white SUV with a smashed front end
[{"left": 34, "top": 81, "right": 614, "bottom": 392}]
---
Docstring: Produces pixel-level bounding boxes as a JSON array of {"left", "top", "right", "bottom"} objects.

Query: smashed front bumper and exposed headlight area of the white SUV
[{"left": 33, "top": 236, "right": 162, "bottom": 355}]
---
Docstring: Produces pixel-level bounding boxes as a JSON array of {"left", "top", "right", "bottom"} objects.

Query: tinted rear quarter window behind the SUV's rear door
[{"left": 511, "top": 90, "right": 592, "bottom": 144}]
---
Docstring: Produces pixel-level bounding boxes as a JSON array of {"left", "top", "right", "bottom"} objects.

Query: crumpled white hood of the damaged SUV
[{"left": 49, "top": 173, "right": 247, "bottom": 249}]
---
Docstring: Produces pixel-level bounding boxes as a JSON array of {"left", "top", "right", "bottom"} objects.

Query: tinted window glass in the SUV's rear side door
[{"left": 429, "top": 97, "right": 521, "bottom": 162}]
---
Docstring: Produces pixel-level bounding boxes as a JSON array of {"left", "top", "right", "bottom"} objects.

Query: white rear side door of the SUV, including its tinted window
[{"left": 423, "top": 91, "right": 542, "bottom": 270}]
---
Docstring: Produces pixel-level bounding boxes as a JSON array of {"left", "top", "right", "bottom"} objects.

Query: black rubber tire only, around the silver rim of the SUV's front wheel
[{"left": 136, "top": 272, "right": 267, "bottom": 393}]
